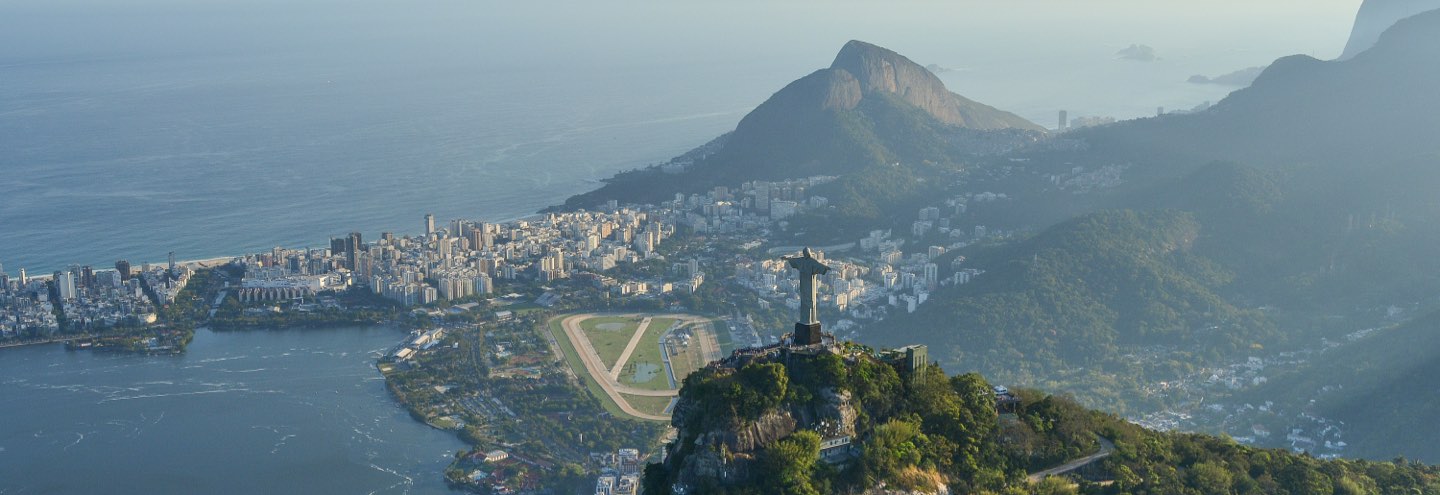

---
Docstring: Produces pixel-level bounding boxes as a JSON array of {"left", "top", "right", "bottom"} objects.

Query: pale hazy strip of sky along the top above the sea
[{"left": 0, "top": 0, "right": 1359, "bottom": 62}]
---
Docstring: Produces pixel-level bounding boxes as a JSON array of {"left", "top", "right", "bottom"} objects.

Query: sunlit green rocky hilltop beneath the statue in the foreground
[{"left": 644, "top": 344, "right": 1440, "bottom": 495}]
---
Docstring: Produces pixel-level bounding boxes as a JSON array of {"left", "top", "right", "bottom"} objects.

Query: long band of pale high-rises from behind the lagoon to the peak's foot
[{"left": 236, "top": 177, "right": 861, "bottom": 305}]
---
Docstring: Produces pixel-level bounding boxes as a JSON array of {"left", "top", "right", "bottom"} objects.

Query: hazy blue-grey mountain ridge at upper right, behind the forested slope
[{"left": 1074, "top": 10, "right": 1440, "bottom": 177}]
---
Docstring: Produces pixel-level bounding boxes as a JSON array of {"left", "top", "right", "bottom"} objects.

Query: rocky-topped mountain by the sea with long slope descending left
[{"left": 555, "top": 40, "right": 1045, "bottom": 209}]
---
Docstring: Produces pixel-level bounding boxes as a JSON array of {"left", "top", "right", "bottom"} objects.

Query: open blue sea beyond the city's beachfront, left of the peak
[{"left": 0, "top": 33, "right": 746, "bottom": 275}]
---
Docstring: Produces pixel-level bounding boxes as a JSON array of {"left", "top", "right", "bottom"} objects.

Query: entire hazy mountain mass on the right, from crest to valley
[{"left": 846, "top": 12, "right": 1440, "bottom": 425}]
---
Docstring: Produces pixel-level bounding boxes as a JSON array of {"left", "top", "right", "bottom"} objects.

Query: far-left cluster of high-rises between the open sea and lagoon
[{"left": 0, "top": 255, "right": 192, "bottom": 338}]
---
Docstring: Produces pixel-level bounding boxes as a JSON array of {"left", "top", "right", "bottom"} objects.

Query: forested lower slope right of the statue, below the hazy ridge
[{"left": 865, "top": 148, "right": 1440, "bottom": 410}]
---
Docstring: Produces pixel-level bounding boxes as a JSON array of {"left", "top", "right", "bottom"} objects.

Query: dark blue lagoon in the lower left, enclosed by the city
[{"left": 0, "top": 328, "right": 465, "bottom": 494}]
